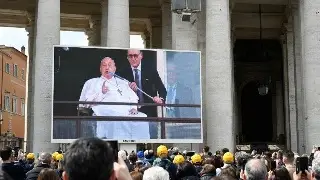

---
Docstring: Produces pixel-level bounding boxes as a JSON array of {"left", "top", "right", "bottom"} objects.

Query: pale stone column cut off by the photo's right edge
[{"left": 299, "top": 0, "right": 320, "bottom": 153}]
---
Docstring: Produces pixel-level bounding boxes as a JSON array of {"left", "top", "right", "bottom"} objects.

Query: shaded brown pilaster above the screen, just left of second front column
[{"left": 85, "top": 16, "right": 101, "bottom": 46}]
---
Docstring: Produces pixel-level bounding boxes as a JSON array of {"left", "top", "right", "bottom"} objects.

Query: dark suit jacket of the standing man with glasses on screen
[{"left": 116, "top": 64, "right": 167, "bottom": 117}]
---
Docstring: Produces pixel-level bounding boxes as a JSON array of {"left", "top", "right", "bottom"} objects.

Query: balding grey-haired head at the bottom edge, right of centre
[{"left": 244, "top": 159, "right": 268, "bottom": 180}]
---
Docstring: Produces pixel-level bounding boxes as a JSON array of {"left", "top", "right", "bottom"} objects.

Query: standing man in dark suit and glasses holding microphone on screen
[{"left": 119, "top": 49, "right": 167, "bottom": 139}]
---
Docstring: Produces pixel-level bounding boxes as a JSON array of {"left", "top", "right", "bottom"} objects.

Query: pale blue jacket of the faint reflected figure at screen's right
[{"left": 169, "top": 83, "right": 197, "bottom": 118}]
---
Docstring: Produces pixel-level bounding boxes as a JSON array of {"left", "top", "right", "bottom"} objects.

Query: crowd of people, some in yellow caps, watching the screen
[{"left": 0, "top": 138, "right": 320, "bottom": 180}]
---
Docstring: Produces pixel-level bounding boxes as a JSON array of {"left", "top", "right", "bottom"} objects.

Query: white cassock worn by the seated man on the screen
[{"left": 79, "top": 76, "right": 150, "bottom": 140}]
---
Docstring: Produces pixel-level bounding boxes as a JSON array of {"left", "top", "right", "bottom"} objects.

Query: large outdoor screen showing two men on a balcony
[{"left": 52, "top": 46, "right": 202, "bottom": 143}]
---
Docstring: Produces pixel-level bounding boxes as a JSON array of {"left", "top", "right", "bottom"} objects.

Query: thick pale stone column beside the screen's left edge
[{"left": 31, "top": 0, "right": 60, "bottom": 153}]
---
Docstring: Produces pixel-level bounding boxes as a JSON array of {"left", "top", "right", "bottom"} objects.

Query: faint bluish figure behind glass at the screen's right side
[{"left": 166, "top": 61, "right": 201, "bottom": 139}]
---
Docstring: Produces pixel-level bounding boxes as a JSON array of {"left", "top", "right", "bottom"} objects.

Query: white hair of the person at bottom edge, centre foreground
[{"left": 143, "top": 166, "right": 170, "bottom": 180}]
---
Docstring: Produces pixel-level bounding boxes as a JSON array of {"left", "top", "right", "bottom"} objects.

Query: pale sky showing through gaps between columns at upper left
[{"left": 0, "top": 27, "right": 144, "bottom": 54}]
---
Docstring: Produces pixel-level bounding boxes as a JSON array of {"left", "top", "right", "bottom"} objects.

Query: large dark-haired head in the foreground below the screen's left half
[{"left": 63, "top": 137, "right": 115, "bottom": 180}]
